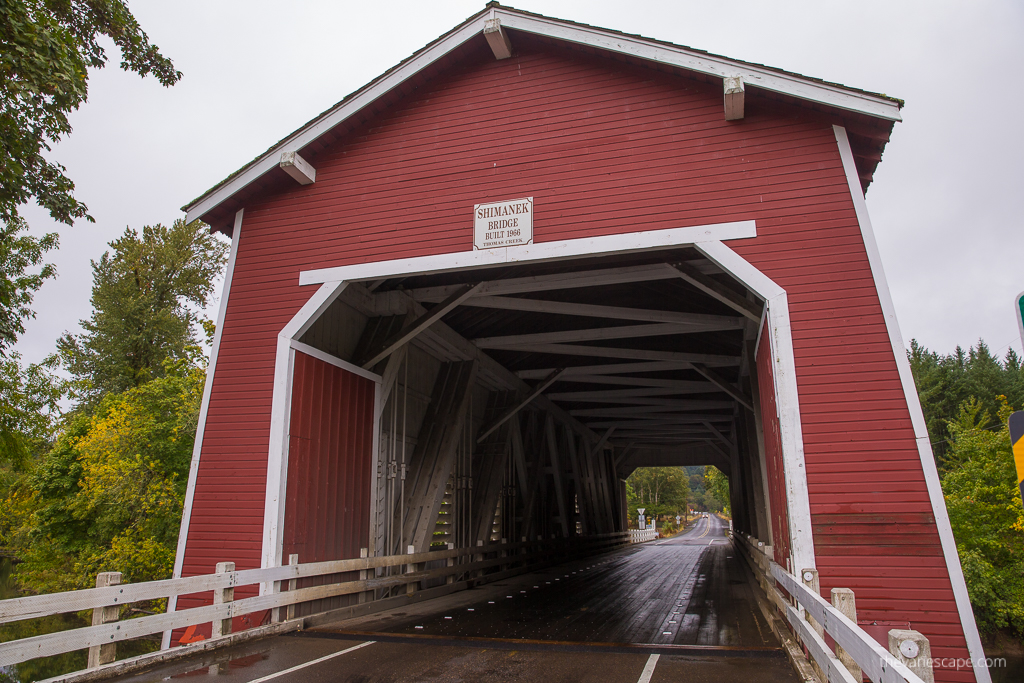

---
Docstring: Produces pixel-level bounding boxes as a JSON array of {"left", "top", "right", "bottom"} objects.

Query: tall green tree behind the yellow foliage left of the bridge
[{"left": 57, "top": 220, "right": 226, "bottom": 405}]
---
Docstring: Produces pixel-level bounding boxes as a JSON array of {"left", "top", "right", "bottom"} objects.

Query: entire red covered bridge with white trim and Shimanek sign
[{"left": 159, "top": 3, "right": 988, "bottom": 681}]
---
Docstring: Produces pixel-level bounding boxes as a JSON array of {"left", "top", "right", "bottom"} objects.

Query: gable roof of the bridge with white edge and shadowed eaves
[{"left": 182, "top": 1, "right": 903, "bottom": 234}]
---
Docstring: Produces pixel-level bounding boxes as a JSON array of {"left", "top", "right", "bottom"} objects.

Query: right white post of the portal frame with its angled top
[{"left": 694, "top": 242, "right": 817, "bottom": 569}]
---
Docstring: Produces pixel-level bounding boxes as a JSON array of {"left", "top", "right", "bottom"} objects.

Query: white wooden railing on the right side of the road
[{"left": 733, "top": 533, "right": 934, "bottom": 683}]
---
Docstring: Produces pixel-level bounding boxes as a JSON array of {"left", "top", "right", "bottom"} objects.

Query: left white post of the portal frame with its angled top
[{"left": 260, "top": 283, "right": 345, "bottom": 581}]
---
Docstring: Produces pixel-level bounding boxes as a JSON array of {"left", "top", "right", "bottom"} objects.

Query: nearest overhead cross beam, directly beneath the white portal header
[{"left": 408, "top": 263, "right": 679, "bottom": 301}]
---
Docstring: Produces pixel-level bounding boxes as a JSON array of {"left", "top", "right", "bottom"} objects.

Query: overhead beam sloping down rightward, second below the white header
[{"left": 466, "top": 296, "right": 743, "bottom": 332}]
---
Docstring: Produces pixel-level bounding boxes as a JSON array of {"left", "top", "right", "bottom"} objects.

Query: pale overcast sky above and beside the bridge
[{"left": 18, "top": 0, "right": 1024, "bottom": 368}]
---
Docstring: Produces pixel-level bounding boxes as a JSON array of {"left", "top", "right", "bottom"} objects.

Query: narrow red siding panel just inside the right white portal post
[{"left": 757, "top": 321, "right": 801, "bottom": 570}]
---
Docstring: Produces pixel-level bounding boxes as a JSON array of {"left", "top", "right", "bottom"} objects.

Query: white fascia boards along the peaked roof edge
[{"left": 185, "top": 7, "right": 901, "bottom": 221}]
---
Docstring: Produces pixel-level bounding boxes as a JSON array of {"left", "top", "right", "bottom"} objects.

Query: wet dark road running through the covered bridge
[{"left": 105, "top": 517, "right": 799, "bottom": 683}]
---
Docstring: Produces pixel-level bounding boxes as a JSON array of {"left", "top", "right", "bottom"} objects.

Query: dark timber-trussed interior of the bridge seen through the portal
[{"left": 276, "top": 247, "right": 788, "bottom": 630}]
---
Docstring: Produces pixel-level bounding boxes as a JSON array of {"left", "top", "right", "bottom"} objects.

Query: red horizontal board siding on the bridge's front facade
[{"left": 176, "top": 35, "right": 972, "bottom": 681}]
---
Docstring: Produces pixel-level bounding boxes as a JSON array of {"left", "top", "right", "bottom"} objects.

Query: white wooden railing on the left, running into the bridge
[{"left": 0, "top": 532, "right": 629, "bottom": 669}]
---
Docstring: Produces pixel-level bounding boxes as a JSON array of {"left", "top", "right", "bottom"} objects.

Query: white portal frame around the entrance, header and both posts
[{"left": 253, "top": 220, "right": 815, "bottom": 589}]
